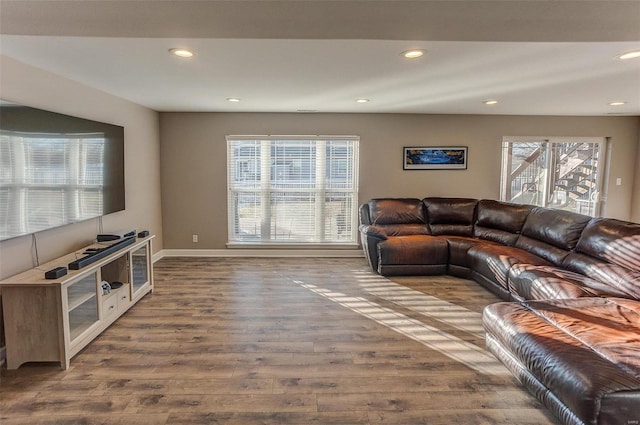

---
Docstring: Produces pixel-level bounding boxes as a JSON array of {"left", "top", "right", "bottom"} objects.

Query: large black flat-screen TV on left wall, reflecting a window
[{"left": 0, "top": 100, "right": 125, "bottom": 240}]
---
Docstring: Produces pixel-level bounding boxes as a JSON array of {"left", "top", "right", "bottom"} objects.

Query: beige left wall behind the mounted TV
[{"left": 0, "top": 56, "right": 162, "bottom": 278}]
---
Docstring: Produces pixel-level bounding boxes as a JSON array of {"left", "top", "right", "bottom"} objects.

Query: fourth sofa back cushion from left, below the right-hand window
[{"left": 515, "top": 207, "right": 591, "bottom": 265}]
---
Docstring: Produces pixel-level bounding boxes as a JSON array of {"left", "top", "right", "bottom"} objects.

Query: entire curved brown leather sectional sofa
[{"left": 360, "top": 198, "right": 640, "bottom": 425}]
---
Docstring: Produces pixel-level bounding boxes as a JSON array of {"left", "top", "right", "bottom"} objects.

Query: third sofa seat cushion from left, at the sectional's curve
[{"left": 467, "top": 244, "right": 551, "bottom": 289}]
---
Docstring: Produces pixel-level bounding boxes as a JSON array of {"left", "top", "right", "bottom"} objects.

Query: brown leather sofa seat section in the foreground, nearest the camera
[{"left": 483, "top": 297, "right": 640, "bottom": 425}]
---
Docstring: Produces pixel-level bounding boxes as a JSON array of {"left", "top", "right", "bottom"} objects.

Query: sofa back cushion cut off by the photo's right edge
[{"left": 563, "top": 218, "right": 640, "bottom": 299}]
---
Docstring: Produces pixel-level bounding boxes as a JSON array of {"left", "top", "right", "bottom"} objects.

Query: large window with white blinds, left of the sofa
[{"left": 227, "top": 136, "right": 359, "bottom": 245}]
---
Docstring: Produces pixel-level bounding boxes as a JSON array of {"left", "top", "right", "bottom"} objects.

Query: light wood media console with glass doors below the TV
[{"left": 0, "top": 236, "right": 154, "bottom": 369}]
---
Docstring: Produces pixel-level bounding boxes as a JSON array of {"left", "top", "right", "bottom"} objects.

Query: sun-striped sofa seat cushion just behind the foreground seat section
[{"left": 508, "top": 264, "right": 629, "bottom": 300}]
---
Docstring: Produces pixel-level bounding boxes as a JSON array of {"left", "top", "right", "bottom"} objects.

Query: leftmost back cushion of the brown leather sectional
[{"left": 367, "top": 198, "right": 429, "bottom": 236}]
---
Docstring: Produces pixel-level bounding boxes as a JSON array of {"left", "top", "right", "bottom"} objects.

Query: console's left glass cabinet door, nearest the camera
[{"left": 66, "top": 273, "right": 98, "bottom": 344}]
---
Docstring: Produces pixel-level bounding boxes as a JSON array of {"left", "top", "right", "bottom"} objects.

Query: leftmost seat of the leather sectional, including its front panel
[{"left": 377, "top": 235, "right": 449, "bottom": 275}]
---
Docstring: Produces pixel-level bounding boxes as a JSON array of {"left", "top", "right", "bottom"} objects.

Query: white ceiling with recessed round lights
[{"left": 0, "top": 0, "right": 640, "bottom": 115}]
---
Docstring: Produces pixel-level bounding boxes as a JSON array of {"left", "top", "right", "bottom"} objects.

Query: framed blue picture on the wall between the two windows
[{"left": 402, "top": 146, "right": 467, "bottom": 170}]
